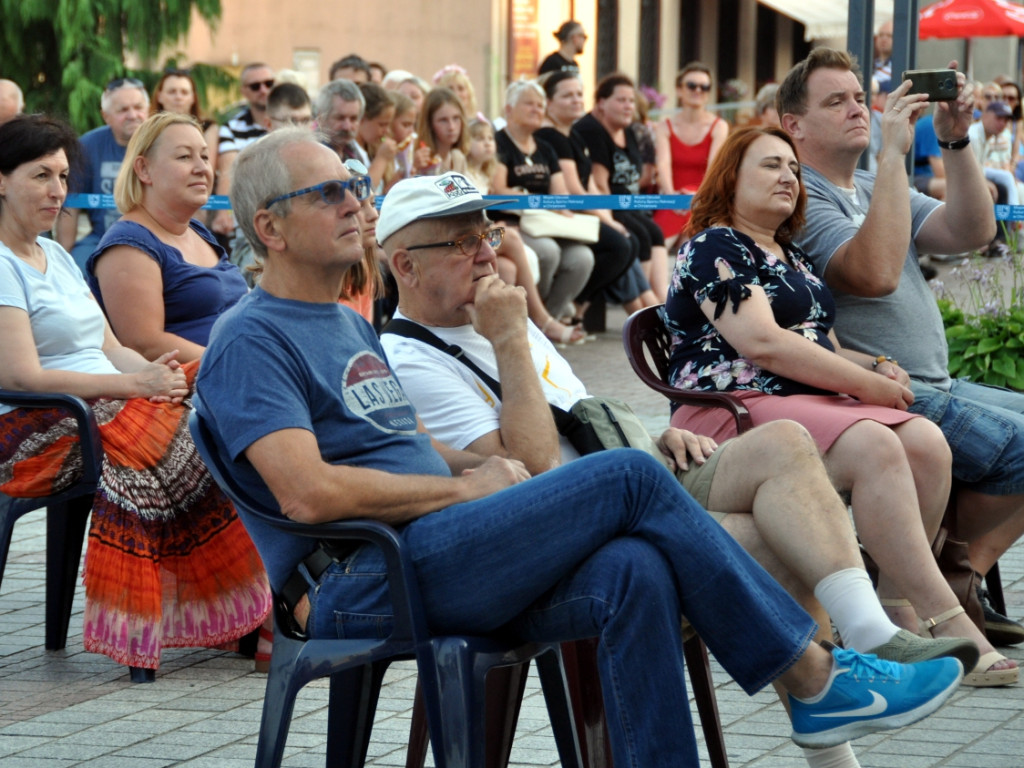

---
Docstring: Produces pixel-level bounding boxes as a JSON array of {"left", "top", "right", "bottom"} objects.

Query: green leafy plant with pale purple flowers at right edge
[{"left": 932, "top": 246, "right": 1024, "bottom": 390}]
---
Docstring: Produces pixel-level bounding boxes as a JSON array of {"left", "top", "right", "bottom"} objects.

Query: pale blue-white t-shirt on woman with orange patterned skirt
[{"left": 0, "top": 238, "right": 118, "bottom": 414}]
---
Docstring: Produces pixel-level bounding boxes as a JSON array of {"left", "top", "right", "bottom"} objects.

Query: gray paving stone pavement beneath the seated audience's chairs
[{"left": 0, "top": 290, "right": 1024, "bottom": 768}]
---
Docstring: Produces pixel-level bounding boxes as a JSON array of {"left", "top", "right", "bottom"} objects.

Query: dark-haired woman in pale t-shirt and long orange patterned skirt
[{"left": 0, "top": 116, "right": 270, "bottom": 679}]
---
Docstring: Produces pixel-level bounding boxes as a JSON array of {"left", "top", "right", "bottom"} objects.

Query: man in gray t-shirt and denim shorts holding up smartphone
[{"left": 776, "top": 48, "right": 1024, "bottom": 644}]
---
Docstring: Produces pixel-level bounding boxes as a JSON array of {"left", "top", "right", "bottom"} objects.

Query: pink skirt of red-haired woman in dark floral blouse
[{"left": 672, "top": 390, "right": 918, "bottom": 454}]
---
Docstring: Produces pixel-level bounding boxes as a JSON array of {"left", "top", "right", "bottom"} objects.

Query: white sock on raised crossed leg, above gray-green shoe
[{"left": 814, "top": 568, "right": 899, "bottom": 653}]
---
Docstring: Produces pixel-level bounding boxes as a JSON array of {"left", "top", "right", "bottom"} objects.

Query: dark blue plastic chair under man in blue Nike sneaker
[{"left": 188, "top": 411, "right": 581, "bottom": 768}]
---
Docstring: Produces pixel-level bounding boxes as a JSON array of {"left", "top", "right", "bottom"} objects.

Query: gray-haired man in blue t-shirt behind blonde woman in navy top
[{"left": 56, "top": 78, "right": 150, "bottom": 272}]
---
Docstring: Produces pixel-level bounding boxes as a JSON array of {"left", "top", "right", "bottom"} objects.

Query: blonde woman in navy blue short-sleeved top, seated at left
[{"left": 86, "top": 112, "right": 247, "bottom": 362}]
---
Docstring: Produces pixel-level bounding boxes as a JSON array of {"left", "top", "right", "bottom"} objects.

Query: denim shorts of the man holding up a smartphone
[{"left": 910, "top": 379, "right": 1024, "bottom": 496}]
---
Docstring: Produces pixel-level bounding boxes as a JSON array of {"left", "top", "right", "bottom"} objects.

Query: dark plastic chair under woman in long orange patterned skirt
[{"left": 0, "top": 389, "right": 103, "bottom": 650}]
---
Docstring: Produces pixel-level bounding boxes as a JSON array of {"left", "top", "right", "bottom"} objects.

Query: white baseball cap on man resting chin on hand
[{"left": 377, "top": 173, "right": 511, "bottom": 243}]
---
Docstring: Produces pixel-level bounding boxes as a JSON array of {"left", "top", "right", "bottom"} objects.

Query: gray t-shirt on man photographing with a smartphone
[{"left": 797, "top": 165, "right": 949, "bottom": 389}]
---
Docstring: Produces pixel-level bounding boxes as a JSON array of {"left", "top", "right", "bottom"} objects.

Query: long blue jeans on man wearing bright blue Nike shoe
[{"left": 308, "top": 450, "right": 816, "bottom": 768}]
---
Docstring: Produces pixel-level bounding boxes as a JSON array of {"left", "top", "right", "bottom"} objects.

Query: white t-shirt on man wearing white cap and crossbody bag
[{"left": 381, "top": 311, "right": 589, "bottom": 463}]
